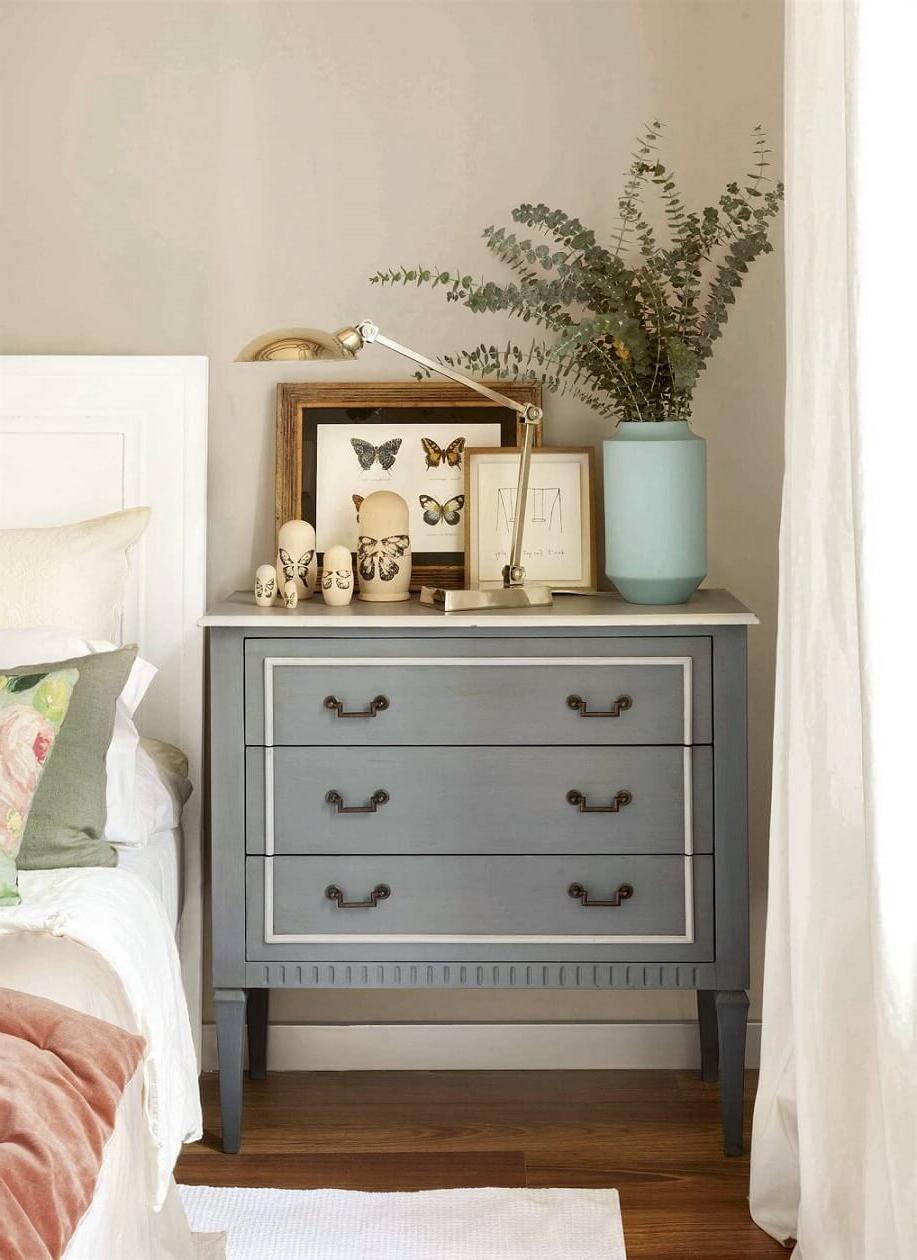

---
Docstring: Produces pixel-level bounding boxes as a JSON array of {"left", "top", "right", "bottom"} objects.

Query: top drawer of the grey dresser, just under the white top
[{"left": 246, "top": 635, "right": 710, "bottom": 746}]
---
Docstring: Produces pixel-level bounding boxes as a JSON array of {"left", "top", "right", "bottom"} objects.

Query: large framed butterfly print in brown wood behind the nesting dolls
[{"left": 275, "top": 381, "right": 542, "bottom": 590}]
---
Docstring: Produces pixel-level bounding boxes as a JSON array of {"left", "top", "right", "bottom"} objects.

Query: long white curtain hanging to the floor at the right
[{"left": 751, "top": 0, "right": 917, "bottom": 1260}]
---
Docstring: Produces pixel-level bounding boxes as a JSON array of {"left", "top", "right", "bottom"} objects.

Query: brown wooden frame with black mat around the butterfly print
[{"left": 275, "top": 381, "right": 542, "bottom": 590}]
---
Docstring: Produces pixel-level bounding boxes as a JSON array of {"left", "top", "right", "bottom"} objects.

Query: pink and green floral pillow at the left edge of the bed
[{"left": 0, "top": 669, "right": 79, "bottom": 906}]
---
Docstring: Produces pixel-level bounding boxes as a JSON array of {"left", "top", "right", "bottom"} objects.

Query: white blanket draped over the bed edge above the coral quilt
[{"left": 0, "top": 868, "right": 202, "bottom": 1207}]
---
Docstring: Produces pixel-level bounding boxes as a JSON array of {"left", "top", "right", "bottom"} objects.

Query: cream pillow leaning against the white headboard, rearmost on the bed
[{"left": 0, "top": 508, "right": 150, "bottom": 640}]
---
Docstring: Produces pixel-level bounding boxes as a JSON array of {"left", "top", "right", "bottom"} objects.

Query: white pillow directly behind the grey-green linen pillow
[{"left": 0, "top": 627, "right": 156, "bottom": 847}]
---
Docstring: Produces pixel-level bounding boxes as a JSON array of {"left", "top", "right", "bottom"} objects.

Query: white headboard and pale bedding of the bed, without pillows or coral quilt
[{"left": 0, "top": 357, "right": 207, "bottom": 1260}]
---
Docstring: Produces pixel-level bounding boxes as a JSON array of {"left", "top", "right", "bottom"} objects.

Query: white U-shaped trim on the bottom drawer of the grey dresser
[{"left": 263, "top": 857, "right": 694, "bottom": 945}]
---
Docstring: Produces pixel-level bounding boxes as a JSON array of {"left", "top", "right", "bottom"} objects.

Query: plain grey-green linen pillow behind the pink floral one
[{"left": 8, "top": 644, "right": 137, "bottom": 871}]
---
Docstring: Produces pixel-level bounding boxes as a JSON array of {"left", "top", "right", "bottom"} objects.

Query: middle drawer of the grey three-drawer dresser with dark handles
[{"left": 246, "top": 746, "right": 713, "bottom": 854}]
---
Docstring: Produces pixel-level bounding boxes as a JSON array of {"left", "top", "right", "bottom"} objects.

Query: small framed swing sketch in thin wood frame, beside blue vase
[{"left": 465, "top": 446, "right": 596, "bottom": 591}]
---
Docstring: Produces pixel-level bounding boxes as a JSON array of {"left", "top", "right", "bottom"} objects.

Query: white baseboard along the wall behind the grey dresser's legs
[{"left": 204, "top": 1021, "right": 761, "bottom": 1072}]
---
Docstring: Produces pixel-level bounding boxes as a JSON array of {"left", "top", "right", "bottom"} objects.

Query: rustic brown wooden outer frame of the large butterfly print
[{"left": 273, "top": 381, "right": 542, "bottom": 590}]
